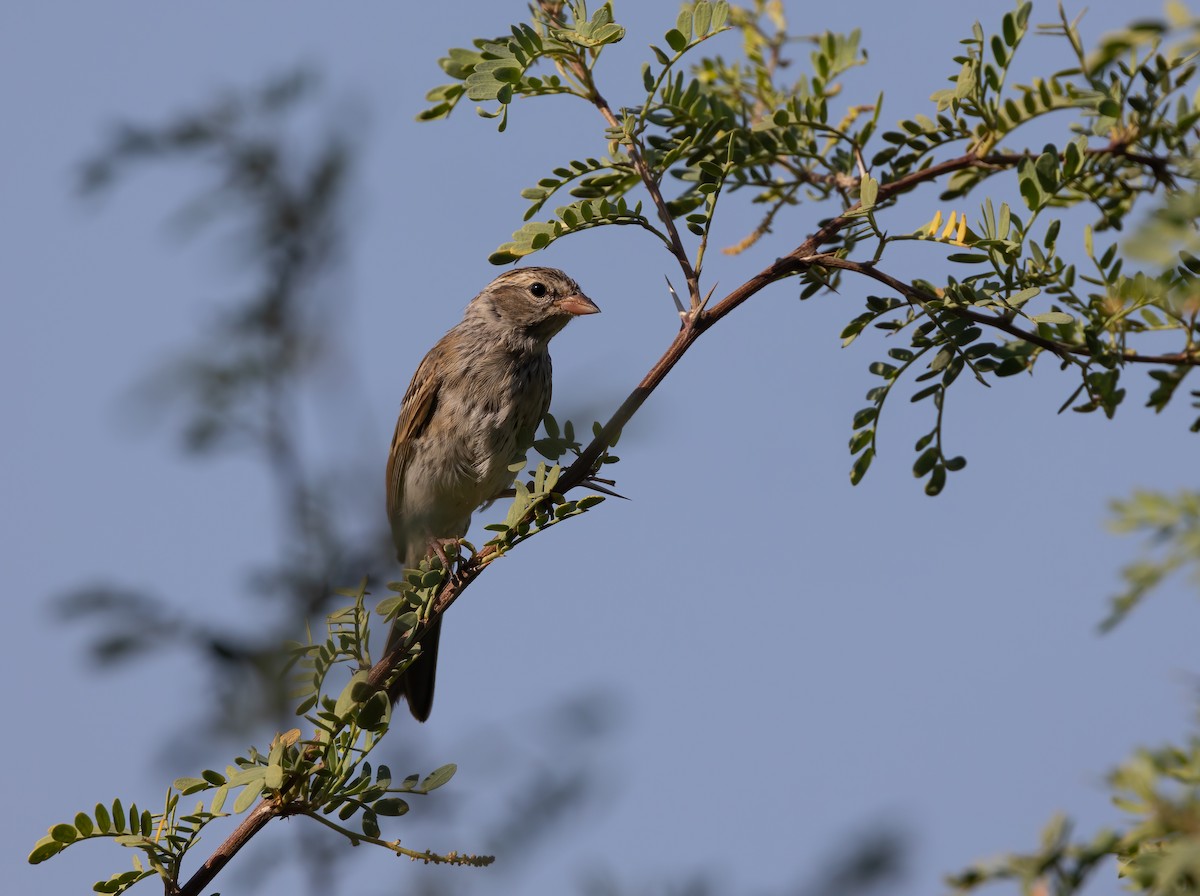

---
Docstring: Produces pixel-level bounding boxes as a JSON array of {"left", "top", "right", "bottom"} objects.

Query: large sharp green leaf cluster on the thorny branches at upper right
[{"left": 417, "top": 0, "right": 1200, "bottom": 494}]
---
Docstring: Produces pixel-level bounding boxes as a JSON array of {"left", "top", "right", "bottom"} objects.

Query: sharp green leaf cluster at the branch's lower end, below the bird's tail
[{"left": 29, "top": 583, "right": 491, "bottom": 894}]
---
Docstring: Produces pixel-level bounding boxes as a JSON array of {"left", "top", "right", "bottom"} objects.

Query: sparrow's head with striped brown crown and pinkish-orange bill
[{"left": 467, "top": 267, "right": 600, "bottom": 344}]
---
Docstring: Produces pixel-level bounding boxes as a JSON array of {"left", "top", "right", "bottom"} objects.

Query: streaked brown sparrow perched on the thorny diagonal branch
[{"left": 388, "top": 267, "right": 600, "bottom": 722}]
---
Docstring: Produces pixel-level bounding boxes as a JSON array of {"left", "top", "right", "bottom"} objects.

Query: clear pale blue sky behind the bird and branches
[{"left": 0, "top": 0, "right": 1200, "bottom": 894}]
